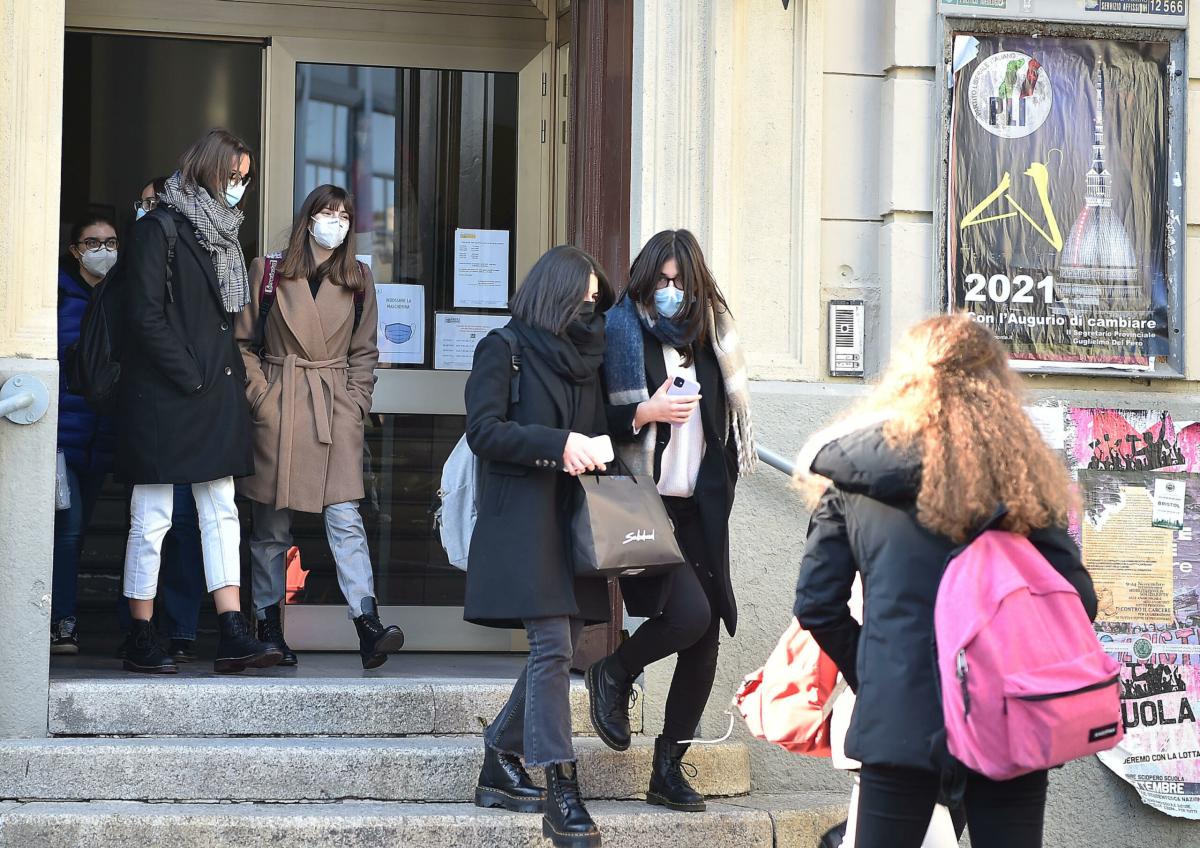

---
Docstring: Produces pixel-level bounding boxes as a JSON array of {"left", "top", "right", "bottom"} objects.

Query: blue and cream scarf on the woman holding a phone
[{"left": 604, "top": 296, "right": 758, "bottom": 475}]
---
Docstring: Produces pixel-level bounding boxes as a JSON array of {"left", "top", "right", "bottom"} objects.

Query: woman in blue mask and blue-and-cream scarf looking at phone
[{"left": 587, "top": 230, "right": 756, "bottom": 812}]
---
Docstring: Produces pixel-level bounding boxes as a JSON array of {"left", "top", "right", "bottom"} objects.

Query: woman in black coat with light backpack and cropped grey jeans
[{"left": 463, "top": 246, "right": 613, "bottom": 848}]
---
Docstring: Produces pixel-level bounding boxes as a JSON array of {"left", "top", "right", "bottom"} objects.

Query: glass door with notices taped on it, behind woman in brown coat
[{"left": 266, "top": 40, "right": 550, "bottom": 650}]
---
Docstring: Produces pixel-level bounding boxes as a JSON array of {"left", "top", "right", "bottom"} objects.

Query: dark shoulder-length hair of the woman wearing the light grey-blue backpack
[{"left": 510, "top": 245, "right": 616, "bottom": 336}]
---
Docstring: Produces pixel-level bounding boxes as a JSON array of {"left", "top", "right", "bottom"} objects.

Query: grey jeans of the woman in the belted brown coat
[{"left": 250, "top": 501, "right": 374, "bottom": 619}]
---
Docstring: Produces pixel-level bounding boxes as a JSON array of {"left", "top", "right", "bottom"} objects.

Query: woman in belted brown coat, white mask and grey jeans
[{"left": 236, "top": 185, "right": 404, "bottom": 668}]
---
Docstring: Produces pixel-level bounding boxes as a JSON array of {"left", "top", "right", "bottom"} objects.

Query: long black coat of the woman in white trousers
[{"left": 116, "top": 206, "right": 254, "bottom": 483}]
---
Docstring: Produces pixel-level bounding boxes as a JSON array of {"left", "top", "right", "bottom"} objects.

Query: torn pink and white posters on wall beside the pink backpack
[{"left": 1064, "top": 409, "right": 1200, "bottom": 819}]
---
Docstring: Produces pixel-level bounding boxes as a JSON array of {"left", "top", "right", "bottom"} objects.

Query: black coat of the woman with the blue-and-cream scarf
[{"left": 608, "top": 330, "right": 738, "bottom": 636}]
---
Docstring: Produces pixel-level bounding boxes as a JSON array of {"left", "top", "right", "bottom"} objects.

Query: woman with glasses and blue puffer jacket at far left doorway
[{"left": 50, "top": 215, "right": 119, "bottom": 654}]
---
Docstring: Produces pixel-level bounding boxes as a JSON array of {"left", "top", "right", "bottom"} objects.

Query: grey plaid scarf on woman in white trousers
[{"left": 158, "top": 170, "right": 250, "bottom": 312}]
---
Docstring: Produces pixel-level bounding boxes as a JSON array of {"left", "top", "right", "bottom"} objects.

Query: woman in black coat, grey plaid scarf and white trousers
[{"left": 114, "top": 130, "right": 282, "bottom": 673}]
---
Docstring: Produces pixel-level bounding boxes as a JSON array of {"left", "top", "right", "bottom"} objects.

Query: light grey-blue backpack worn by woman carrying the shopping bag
[{"left": 433, "top": 326, "right": 521, "bottom": 571}]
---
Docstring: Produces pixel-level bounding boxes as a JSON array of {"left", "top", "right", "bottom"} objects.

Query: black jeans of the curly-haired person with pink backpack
[{"left": 856, "top": 765, "right": 1048, "bottom": 848}]
